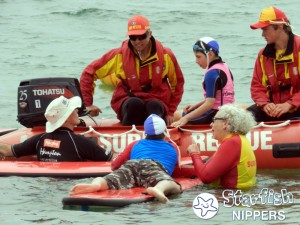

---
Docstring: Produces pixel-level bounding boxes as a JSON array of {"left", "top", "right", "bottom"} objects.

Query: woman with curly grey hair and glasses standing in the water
[{"left": 188, "top": 104, "right": 256, "bottom": 188}]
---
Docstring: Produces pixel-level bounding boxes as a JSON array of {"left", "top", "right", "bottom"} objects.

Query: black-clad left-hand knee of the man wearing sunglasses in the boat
[{"left": 121, "top": 97, "right": 146, "bottom": 126}]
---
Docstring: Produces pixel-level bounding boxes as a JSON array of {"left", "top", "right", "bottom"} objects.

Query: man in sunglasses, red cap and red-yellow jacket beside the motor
[{"left": 80, "top": 15, "right": 184, "bottom": 125}]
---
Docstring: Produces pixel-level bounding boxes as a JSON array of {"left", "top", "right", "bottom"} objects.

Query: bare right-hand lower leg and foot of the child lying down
[{"left": 147, "top": 180, "right": 181, "bottom": 202}]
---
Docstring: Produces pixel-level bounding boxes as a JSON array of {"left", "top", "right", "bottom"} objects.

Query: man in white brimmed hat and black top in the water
[{"left": 0, "top": 96, "right": 113, "bottom": 162}]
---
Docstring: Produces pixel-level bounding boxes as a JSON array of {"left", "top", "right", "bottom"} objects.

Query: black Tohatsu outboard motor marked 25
[{"left": 18, "top": 77, "right": 87, "bottom": 128}]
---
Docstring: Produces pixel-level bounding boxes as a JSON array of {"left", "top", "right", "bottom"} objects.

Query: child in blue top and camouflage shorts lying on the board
[{"left": 70, "top": 114, "right": 181, "bottom": 202}]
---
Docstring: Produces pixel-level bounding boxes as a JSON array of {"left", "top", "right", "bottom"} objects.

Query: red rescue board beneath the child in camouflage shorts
[{"left": 62, "top": 177, "right": 203, "bottom": 211}]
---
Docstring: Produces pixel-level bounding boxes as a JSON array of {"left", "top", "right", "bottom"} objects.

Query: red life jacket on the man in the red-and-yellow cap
[{"left": 259, "top": 35, "right": 300, "bottom": 103}]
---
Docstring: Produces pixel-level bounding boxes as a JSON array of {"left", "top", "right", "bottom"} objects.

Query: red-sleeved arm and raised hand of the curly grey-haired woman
[{"left": 188, "top": 138, "right": 241, "bottom": 183}]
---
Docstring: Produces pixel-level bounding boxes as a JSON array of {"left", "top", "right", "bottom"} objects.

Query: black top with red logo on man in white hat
[{"left": 12, "top": 128, "right": 112, "bottom": 162}]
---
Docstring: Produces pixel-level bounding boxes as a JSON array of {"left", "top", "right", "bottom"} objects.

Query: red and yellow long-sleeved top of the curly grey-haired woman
[{"left": 191, "top": 134, "right": 256, "bottom": 188}]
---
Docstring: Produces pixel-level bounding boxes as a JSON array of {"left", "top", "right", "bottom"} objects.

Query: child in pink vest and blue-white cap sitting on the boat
[{"left": 172, "top": 37, "right": 234, "bottom": 127}]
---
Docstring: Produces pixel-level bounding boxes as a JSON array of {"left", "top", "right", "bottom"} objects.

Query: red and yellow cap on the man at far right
[{"left": 250, "top": 6, "right": 288, "bottom": 30}]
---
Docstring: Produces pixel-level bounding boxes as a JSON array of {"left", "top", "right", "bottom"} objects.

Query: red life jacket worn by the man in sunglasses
[{"left": 111, "top": 39, "right": 172, "bottom": 119}]
